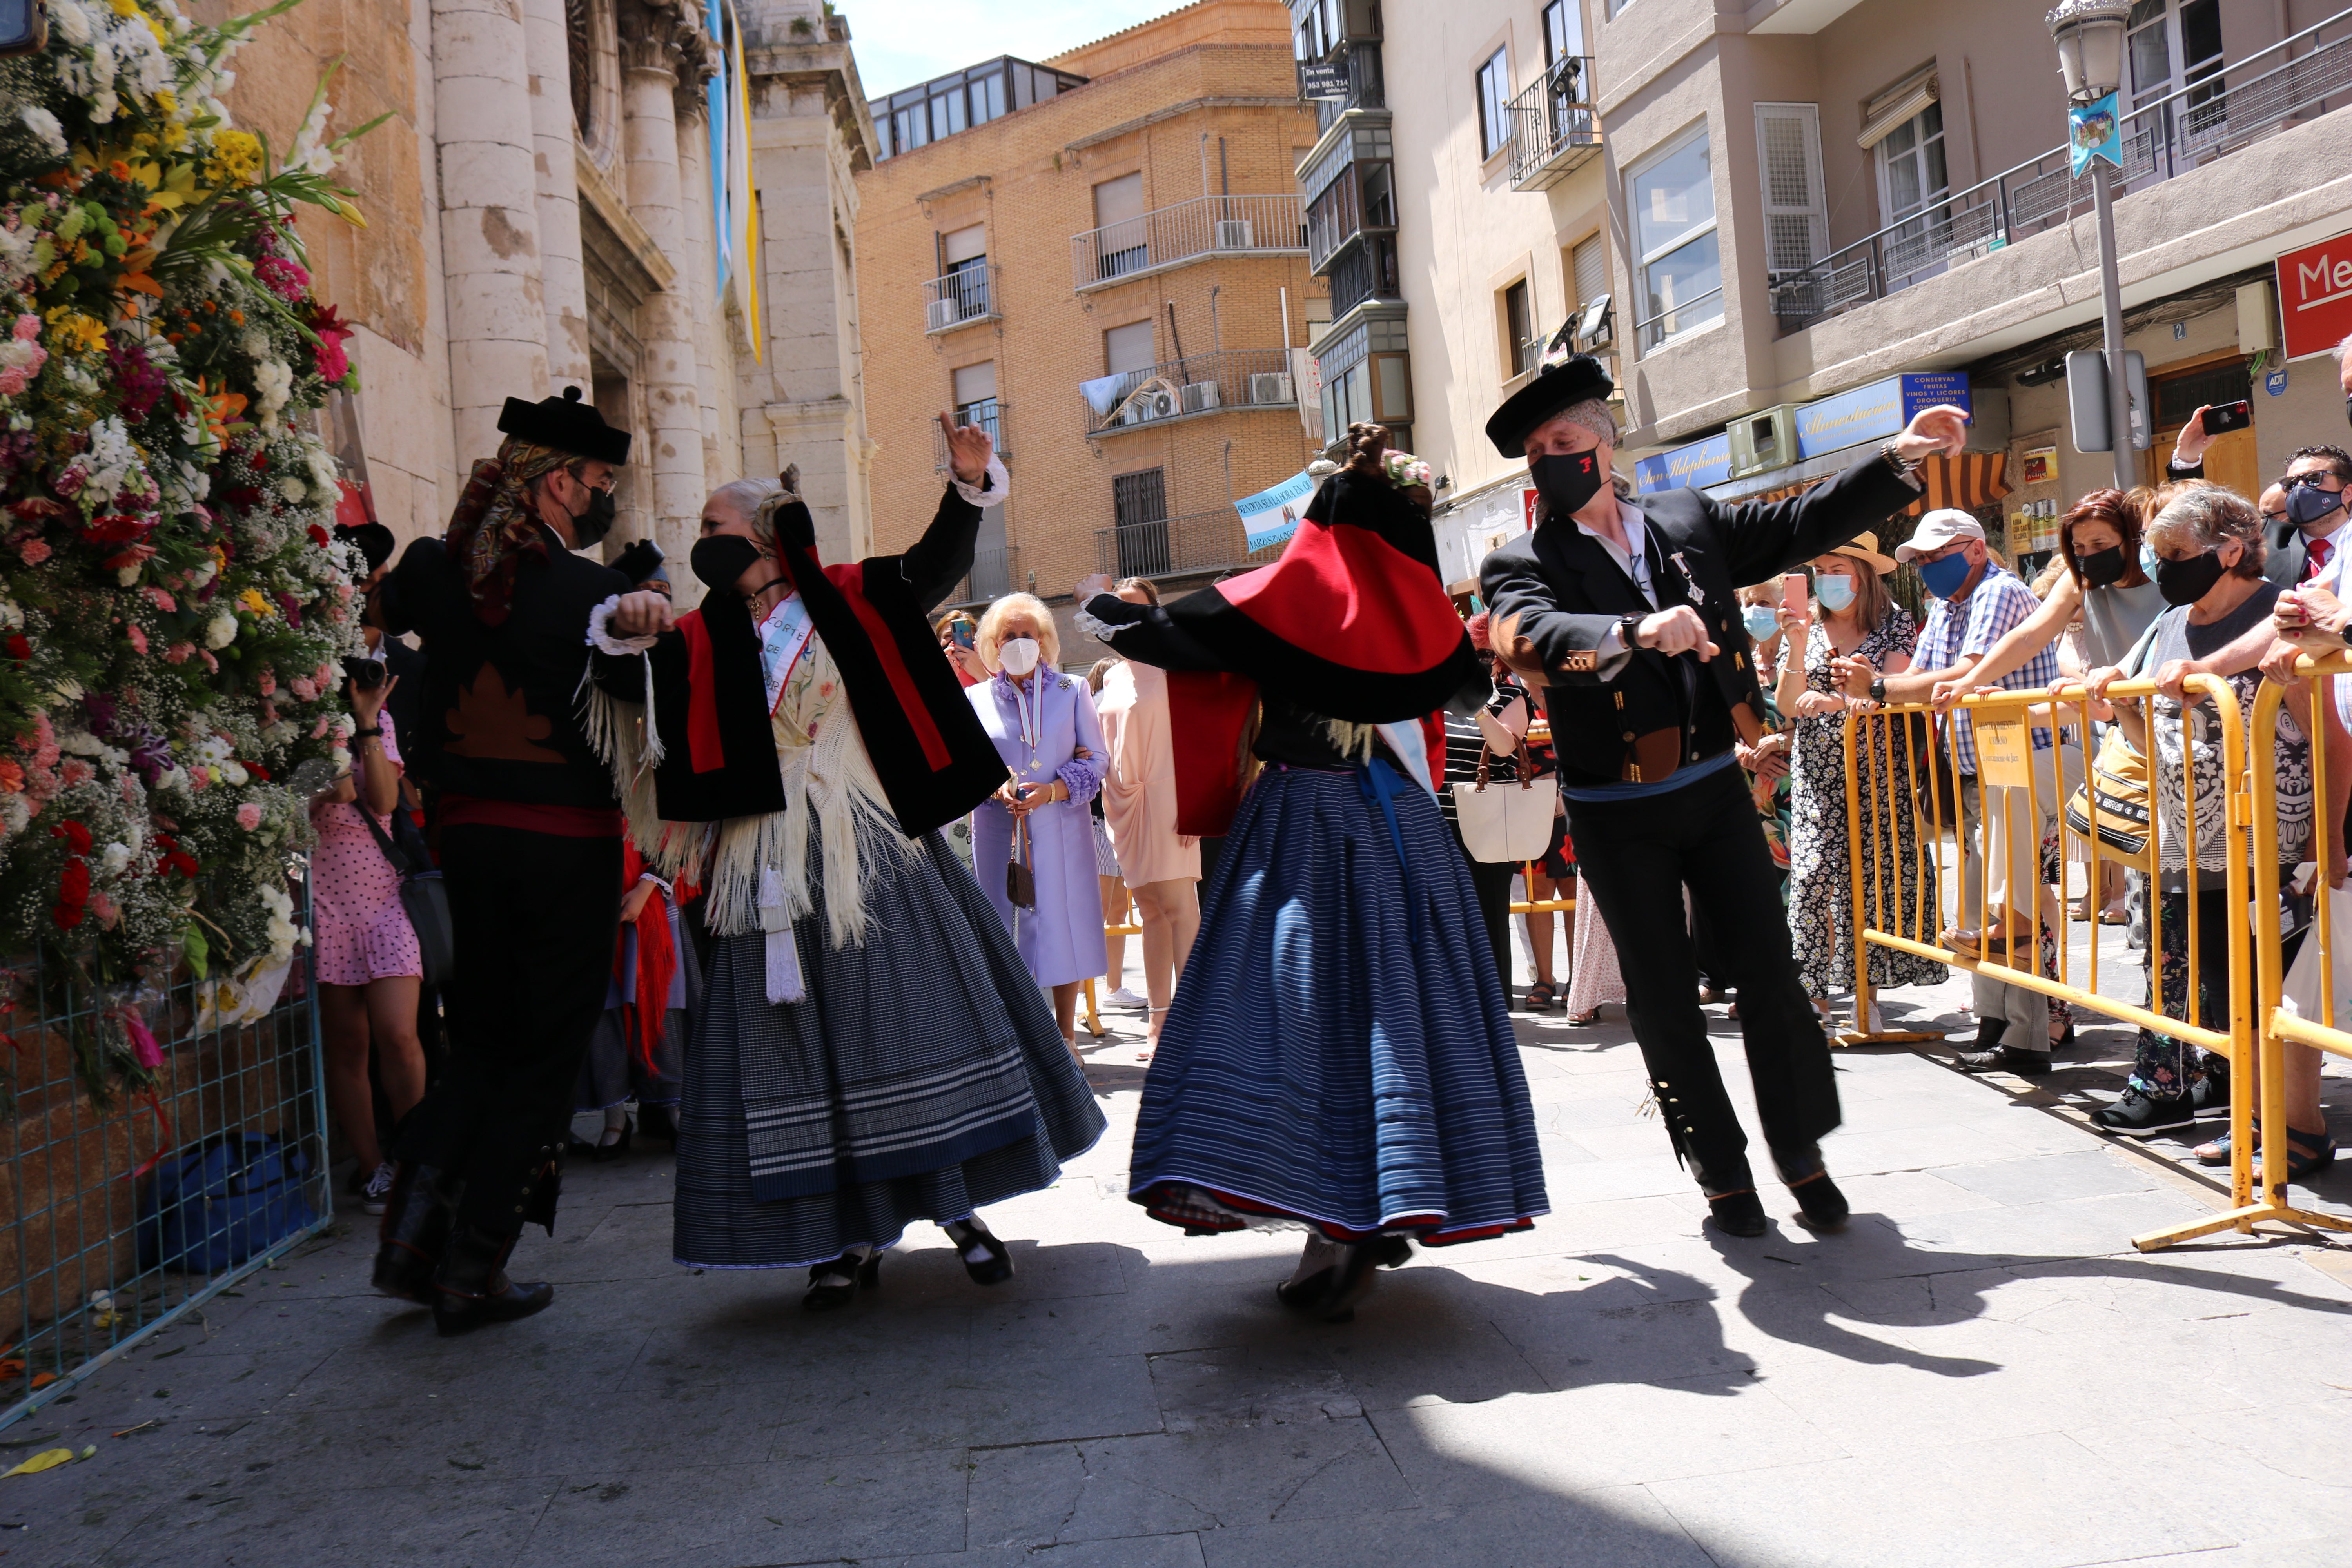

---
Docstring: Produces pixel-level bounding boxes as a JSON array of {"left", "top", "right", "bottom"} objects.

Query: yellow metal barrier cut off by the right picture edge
[{"left": 2131, "top": 653, "right": 2352, "bottom": 1253}]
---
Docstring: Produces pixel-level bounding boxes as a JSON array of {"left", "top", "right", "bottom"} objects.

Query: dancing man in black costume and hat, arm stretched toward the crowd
[{"left": 1479, "top": 334, "right": 1966, "bottom": 1236}]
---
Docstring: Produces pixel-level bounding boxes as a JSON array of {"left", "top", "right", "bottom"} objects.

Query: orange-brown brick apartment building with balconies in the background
[{"left": 856, "top": 0, "right": 1327, "bottom": 665}]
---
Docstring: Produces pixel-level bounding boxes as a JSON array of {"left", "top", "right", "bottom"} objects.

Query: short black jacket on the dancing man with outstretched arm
[{"left": 1479, "top": 456, "right": 1919, "bottom": 788}]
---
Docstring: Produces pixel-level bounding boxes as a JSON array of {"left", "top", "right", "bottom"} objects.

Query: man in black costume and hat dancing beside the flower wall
[{"left": 374, "top": 388, "right": 670, "bottom": 1333}]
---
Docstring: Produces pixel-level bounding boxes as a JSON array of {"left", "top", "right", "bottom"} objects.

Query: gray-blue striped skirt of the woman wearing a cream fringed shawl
[{"left": 675, "top": 832, "right": 1103, "bottom": 1269}]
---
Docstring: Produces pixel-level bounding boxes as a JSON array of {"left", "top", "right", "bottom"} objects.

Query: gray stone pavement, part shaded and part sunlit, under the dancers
[{"left": 0, "top": 940, "right": 2352, "bottom": 1568}]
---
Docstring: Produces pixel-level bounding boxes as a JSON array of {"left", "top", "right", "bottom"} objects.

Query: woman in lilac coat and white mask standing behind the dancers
[{"left": 964, "top": 592, "right": 1108, "bottom": 1053}]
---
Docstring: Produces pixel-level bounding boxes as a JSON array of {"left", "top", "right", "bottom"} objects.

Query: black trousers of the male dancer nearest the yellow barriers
[{"left": 1569, "top": 769, "right": 1839, "bottom": 1194}]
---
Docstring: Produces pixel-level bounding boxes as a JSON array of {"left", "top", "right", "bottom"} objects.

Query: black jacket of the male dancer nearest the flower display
[{"left": 379, "top": 524, "right": 628, "bottom": 809}]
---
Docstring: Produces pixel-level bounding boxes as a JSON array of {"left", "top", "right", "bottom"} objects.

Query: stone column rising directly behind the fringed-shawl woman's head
[{"left": 621, "top": 5, "right": 708, "bottom": 588}]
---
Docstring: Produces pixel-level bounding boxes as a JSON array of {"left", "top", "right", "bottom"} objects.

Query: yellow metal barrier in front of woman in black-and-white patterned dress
[{"left": 1839, "top": 665, "right": 2267, "bottom": 1248}]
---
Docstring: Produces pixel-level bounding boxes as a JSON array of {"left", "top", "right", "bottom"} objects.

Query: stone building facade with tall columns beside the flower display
[{"left": 216, "top": 0, "right": 873, "bottom": 602}]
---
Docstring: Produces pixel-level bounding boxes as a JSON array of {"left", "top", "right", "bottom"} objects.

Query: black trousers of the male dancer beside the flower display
[{"left": 400, "top": 825, "right": 621, "bottom": 1236}]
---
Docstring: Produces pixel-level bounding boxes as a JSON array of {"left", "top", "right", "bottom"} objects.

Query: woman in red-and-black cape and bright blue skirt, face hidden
[{"left": 1077, "top": 425, "right": 1545, "bottom": 1321}]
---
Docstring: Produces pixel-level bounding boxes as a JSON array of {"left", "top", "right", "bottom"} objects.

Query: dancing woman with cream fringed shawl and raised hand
[{"left": 590, "top": 421, "right": 1103, "bottom": 1309}]
